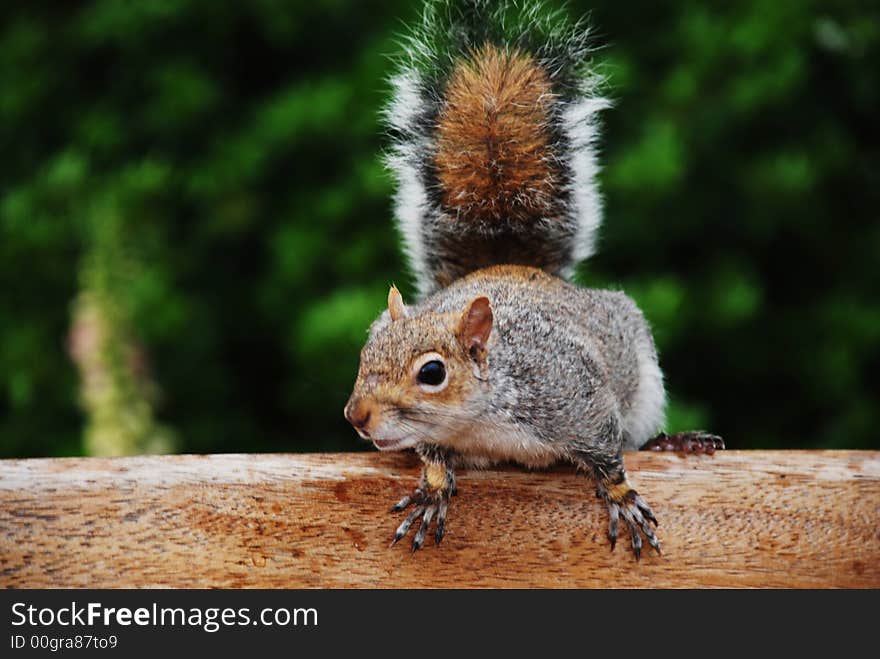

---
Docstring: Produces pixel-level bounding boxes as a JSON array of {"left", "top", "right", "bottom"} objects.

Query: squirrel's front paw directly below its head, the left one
[{"left": 391, "top": 464, "right": 455, "bottom": 551}]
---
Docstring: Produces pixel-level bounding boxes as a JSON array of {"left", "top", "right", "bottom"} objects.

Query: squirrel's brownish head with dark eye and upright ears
[{"left": 345, "top": 286, "right": 493, "bottom": 451}]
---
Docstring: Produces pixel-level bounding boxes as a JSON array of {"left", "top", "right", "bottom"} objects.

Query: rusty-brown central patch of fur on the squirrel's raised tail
[{"left": 435, "top": 44, "right": 560, "bottom": 222}]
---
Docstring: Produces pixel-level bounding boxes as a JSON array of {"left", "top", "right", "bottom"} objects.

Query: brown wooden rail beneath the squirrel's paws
[{"left": 0, "top": 451, "right": 880, "bottom": 588}]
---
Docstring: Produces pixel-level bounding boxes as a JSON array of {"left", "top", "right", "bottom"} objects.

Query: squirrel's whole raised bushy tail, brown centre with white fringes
[{"left": 385, "top": 0, "right": 609, "bottom": 295}]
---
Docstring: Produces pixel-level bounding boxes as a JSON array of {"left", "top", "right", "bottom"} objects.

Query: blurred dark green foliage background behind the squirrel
[{"left": 0, "top": 0, "right": 880, "bottom": 457}]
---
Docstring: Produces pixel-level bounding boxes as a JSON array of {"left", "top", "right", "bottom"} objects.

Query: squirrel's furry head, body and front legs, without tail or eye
[{"left": 345, "top": 265, "right": 664, "bottom": 560}]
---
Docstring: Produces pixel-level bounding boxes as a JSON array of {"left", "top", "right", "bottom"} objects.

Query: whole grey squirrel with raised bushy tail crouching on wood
[{"left": 344, "top": 0, "right": 723, "bottom": 559}]
